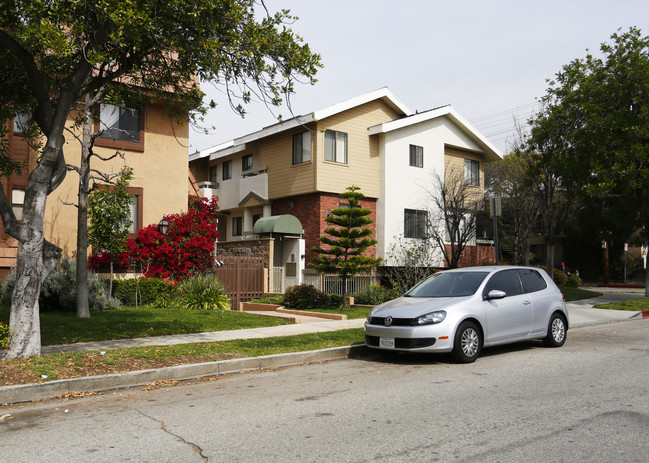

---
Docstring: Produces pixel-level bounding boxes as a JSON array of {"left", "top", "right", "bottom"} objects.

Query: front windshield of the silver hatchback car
[{"left": 405, "top": 272, "right": 489, "bottom": 297}]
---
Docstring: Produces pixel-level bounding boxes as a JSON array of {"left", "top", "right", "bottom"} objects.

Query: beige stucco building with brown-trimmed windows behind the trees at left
[{"left": 0, "top": 100, "right": 192, "bottom": 274}]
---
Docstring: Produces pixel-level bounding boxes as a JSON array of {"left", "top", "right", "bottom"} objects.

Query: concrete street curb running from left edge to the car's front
[{"left": 0, "top": 344, "right": 366, "bottom": 404}]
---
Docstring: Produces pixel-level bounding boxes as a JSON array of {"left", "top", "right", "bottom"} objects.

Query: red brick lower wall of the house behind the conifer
[{"left": 271, "top": 193, "right": 376, "bottom": 264}]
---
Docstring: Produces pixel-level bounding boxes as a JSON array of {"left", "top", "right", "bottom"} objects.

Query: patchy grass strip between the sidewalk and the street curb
[{"left": 0, "top": 328, "right": 364, "bottom": 386}]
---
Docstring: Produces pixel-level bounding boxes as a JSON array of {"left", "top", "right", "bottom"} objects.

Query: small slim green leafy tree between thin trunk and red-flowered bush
[{"left": 88, "top": 168, "right": 133, "bottom": 300}]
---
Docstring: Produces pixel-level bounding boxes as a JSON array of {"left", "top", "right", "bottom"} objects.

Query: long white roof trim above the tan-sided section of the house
[{"left": 189, "top": 87, "right": 410, "bottom": 161}]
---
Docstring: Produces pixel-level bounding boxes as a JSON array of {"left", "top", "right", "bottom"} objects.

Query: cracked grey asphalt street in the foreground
[{"left": 0, "top": 319, "right": 649, "bottom": 463}]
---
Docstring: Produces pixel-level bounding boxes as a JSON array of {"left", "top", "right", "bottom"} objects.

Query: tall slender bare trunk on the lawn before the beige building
[{"left": 77, "top": 95, "right": 94, "bottom": 318}]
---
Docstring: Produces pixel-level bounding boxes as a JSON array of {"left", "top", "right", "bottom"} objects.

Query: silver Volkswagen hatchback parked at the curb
[{"left": 365, "top": 266, "right": 568, "bottom": 363}]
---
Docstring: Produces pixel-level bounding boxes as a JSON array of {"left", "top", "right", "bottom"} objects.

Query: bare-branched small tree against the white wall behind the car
[{"left": 426, "top": 164, "right": 483, "bottom": 268}]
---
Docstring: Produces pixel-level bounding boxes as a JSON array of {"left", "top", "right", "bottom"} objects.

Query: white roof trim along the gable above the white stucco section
[{"left": 368, "top": 105, "right": 503, "bottom": 161}]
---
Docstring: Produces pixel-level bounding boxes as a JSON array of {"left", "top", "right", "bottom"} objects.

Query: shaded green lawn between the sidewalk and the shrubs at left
[{"left": 0, "top": 307, "right": 290, "bottom": 346}]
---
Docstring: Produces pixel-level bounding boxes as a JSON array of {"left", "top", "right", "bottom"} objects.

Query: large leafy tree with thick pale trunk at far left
[{"left": 0, "top": 0, "right": 320, "bottom": 358}]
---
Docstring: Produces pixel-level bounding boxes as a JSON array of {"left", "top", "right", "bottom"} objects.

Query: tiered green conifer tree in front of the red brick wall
[{"left": 309, "top": 185, "right": 381, "bottom": 310}]
